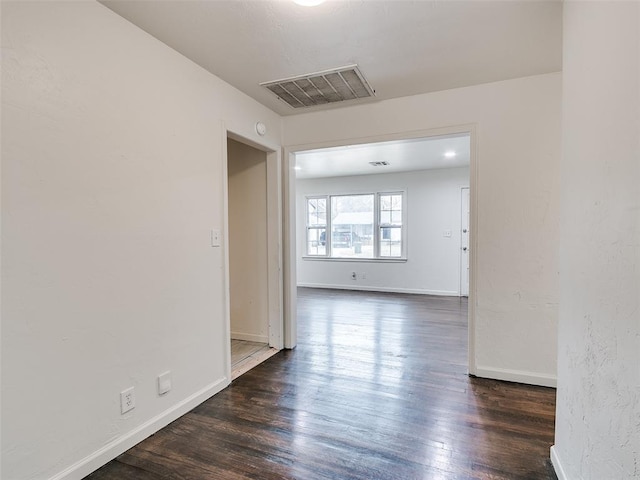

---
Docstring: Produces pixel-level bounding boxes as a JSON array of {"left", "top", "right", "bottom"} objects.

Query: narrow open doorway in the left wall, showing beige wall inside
[{"left": 225, "top": 135, "right": 282, "bottom": 380}]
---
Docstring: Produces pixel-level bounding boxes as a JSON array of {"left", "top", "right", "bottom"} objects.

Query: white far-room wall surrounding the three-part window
[{"left": 296, "top": 167, "right": 469, "bottom": 295}]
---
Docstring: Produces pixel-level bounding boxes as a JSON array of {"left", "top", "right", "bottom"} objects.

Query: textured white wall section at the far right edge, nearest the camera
[{"left": 552, "top": 1, "right": 640, "bottom": 480}]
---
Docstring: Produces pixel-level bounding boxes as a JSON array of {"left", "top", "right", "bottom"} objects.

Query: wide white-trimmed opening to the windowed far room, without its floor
[{"left": 285, "top": 125, "right": 476, "bottom": 373}]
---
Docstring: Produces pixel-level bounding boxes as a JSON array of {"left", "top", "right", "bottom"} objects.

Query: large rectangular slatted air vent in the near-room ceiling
[{"left": 260, "top": 65, "right": 375, "bottom": 108}]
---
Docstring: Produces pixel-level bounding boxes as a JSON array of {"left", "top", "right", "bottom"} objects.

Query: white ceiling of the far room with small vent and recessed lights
[{"left": 296, "top": 135, "right": 470, "bottom": 179}]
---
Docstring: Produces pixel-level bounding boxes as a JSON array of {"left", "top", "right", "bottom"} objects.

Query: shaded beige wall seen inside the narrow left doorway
[{"left": 227, "top": 139, "right": 269, "bottom": 343}]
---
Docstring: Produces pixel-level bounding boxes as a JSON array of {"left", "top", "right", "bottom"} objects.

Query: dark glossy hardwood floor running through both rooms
[{"left": 87, "top": 288, "right": 556, "bottom": 480}]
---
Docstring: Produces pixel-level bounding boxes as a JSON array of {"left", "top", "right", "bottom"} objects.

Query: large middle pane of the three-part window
[{"left": 331, "top": 195, "right": 374, "bottom": 258}]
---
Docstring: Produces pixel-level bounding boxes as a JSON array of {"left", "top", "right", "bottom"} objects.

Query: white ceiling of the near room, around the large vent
[{"left": 101, "top": 0, "right": 562, "bottom": 115}]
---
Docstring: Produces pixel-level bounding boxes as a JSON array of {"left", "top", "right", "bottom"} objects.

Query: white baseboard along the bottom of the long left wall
[{"left": 49, "top": 377, "right": 229, "bottom": 480}]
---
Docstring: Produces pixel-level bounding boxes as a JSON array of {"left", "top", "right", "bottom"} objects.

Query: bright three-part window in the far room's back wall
[{"left": 306, "top": 192, "right": 405, "bottom": 259}]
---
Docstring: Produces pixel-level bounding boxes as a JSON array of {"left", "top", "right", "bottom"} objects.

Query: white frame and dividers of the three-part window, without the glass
[{"left": 303, "top": 190, "right": 408, "bottom": 263}]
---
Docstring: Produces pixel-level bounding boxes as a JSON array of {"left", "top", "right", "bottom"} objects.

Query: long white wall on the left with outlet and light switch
[{"left": 2, "top": 2, "right": 280, "bottom": 480}]
